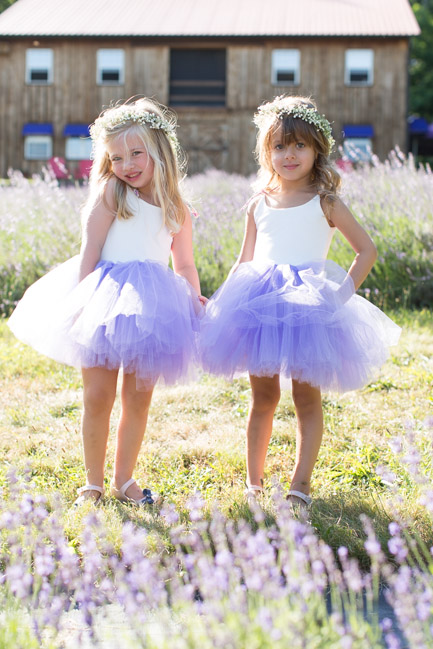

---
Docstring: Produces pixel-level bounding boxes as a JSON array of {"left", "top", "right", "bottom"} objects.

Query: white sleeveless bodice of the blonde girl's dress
[{"left": 101, "top": 190, "right": 173, "bottom": 265}]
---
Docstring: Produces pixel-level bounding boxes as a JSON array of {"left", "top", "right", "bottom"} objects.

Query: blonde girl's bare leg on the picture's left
[{"left": 81, "top": 367, "right": 118, "bottom": 499}]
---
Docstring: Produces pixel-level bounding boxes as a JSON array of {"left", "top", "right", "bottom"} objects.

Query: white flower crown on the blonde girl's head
[{"left": 90, "top": 105, "right": 179, "bottom": 151}]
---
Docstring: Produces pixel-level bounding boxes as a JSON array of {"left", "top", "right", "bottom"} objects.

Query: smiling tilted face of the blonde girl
[{"left": 107, "top": 133, "right": 155, "bottom": 198}]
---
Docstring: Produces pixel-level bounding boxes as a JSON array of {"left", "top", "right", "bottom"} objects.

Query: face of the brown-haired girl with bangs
[{"left": 270, "top": 128, "right": 316, "bottom": 184}]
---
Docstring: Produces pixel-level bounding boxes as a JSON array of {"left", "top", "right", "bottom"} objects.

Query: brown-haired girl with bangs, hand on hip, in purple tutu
[{"left": 201, "top": 96, "right": 399, "bottom": 506}]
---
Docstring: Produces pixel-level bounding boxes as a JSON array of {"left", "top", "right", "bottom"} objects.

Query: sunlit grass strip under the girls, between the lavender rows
[{"left": 0, "top": 310, "right": 433, "bottom": 565}]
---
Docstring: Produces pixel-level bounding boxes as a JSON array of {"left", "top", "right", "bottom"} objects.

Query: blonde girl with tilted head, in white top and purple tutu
[{"left": 9, "top": 99, "right": 201, "bottom": 505}]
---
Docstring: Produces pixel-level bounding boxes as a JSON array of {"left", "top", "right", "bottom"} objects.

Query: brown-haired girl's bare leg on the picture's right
[{"left": 290, "top": 380, "right": 323, "bottom": 494}]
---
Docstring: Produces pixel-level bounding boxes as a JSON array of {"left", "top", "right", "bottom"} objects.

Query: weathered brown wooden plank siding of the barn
[{"left": 0, "top": 38, "right": 408, "bottom": 177}]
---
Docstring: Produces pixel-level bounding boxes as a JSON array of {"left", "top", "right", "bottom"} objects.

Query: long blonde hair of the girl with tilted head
[{"left": 89, "top": 98, "right": 185, "bottom": 233}]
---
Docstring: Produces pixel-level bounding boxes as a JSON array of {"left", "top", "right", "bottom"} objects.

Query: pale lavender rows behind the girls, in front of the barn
[{"left": 0, "top": 151, "right": 433, "bottom": 315}]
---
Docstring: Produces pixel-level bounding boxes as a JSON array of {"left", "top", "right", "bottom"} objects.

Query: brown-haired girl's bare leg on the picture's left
[{"left": 247, "top": 374, "right": 280, "bottom": 486}]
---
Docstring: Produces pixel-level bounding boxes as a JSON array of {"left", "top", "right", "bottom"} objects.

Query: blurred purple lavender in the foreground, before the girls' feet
[{"left": 0, "top": 419, "right": 433, "bottom": 649}]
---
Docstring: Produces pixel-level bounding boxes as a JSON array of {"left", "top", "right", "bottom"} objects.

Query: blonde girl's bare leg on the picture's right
[{"left": 114, "top": 374, "right": 153, "bottom": 498}]
